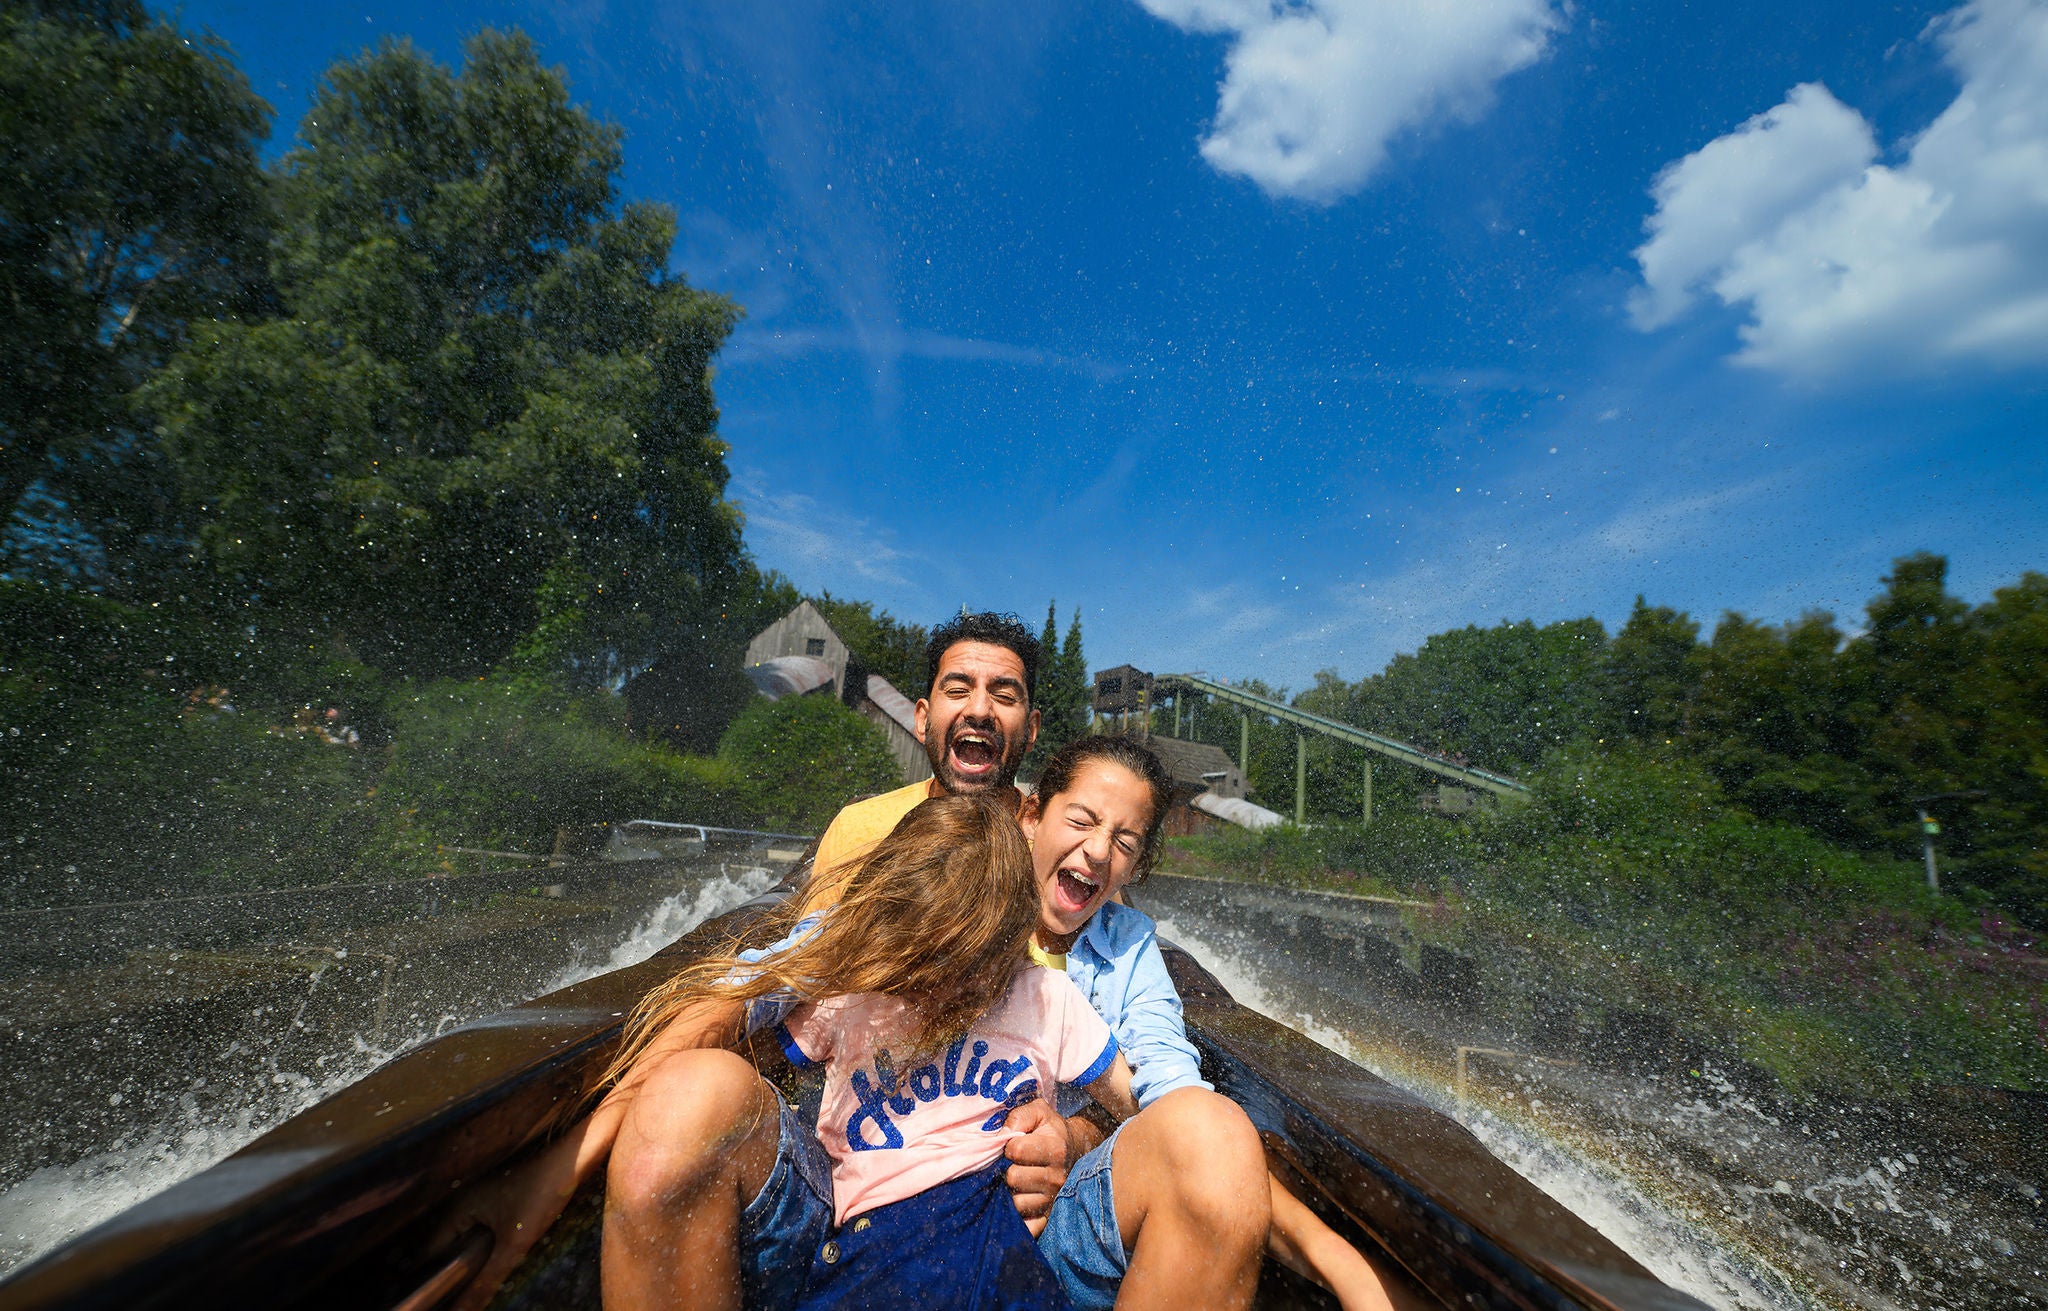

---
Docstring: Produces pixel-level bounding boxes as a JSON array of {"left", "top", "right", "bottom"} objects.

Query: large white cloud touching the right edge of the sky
[{"left": 1630, "top": 0, "right": 2048, "bottom": 379}]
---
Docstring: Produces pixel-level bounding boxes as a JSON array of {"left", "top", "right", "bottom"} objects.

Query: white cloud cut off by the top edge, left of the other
[{"left": 1139, "top": 0, "right": 1563, "bottom": 201}]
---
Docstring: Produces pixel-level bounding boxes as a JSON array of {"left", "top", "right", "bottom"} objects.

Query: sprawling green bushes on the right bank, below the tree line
[{"left": 1176, "top": 744, "right": 2048, "bottom": 1094}]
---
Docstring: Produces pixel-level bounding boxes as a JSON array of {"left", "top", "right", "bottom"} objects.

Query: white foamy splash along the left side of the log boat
[{"left": 0, "top": 864, "right": 776, "bottom": 1274}]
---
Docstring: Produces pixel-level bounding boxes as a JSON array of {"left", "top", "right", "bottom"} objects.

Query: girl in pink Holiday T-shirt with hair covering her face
[{"left": 606, "top": 797, "right": 1137, "bottom": 1307}]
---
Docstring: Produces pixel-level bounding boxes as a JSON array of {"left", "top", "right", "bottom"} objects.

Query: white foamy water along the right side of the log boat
[{"left": 1159, "top": 920, "right": 1815, "bottom": 1311}]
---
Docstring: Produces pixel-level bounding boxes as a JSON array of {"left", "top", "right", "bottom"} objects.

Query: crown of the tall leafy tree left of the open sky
[{"left": 145, "top": 31, "right": 760, "bottom": 684}]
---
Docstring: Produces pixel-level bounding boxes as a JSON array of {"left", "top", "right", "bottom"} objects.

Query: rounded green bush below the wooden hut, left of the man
[{"left": 719, "top": 696, "right": 903, "bottom": 834}]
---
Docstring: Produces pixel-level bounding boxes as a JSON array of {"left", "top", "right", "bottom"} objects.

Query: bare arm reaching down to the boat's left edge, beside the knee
[{"left": 440, "top": 1002, "right": 745, "bottom": 1311}]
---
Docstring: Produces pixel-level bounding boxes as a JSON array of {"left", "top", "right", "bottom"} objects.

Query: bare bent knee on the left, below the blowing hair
[{"left": 604, "top": 1051, "right": 780, "bottom": 1311}]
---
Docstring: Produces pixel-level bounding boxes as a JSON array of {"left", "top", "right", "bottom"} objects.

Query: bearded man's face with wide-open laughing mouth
[{"left": 918, "top": 641, "right": 1038, "bottom": 793}]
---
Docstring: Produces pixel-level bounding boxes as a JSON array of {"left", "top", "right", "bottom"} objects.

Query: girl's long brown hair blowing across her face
[{"left": 604, "top": 795, "right": 1038, "bottom": 1084}]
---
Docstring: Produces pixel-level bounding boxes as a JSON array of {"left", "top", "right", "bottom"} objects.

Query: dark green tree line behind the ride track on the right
[{"left": 1187, "top": 553, "right": 2048, "bottom": 924}]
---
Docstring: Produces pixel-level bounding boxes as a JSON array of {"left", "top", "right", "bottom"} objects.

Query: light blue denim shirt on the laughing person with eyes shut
[{"left": 739, "top": 901, "right": 1208, "bottom": 1114}]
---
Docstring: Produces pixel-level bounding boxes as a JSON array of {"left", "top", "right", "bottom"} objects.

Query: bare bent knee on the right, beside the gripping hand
[{"left": 1110, "top": 1088, "right": 1272, "bottom": 1311}]
